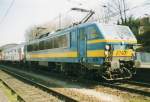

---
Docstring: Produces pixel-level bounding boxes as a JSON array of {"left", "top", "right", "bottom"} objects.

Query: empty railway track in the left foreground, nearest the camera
[{"left": 0, "top": 69, "right": 77, "bottom": 102}]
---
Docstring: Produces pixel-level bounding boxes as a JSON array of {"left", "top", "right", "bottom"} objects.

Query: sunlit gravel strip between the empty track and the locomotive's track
[{"left": 22, "top": 70, "right": 150, "bottom": 102}]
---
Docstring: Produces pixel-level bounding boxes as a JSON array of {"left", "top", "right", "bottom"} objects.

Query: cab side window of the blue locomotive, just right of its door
[{"left": 86, "top": 26, "right": 98, "bottom": 39}]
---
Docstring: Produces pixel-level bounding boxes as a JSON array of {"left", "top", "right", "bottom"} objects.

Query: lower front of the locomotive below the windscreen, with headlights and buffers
[{"left": 103, "top": 44, "right": 136, "bottom": 80}]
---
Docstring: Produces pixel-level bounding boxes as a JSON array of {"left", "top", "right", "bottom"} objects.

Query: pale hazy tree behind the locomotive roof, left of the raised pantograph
[{"left": 25, "top": 16, "right": 72, "bottom": 42}]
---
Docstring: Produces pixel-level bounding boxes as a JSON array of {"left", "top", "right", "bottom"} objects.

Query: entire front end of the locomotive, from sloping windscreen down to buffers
[{"left": 98, "top": 25, "right": 137, "bottom": 80}]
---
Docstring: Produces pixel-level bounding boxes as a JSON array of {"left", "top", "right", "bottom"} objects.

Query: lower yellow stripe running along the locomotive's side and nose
[{"left": 28, "top": 49, "right": 134, "bottom": 58}]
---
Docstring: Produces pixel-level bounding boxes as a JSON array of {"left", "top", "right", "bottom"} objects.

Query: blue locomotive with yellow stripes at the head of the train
[{"left": 25, "top": 22, "right": 137, "bottom": 80}]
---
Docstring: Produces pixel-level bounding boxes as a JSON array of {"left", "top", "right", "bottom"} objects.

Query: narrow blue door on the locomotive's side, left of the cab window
[{"left": 78, "top": 28, "right": 86, "bottom": 62}]
